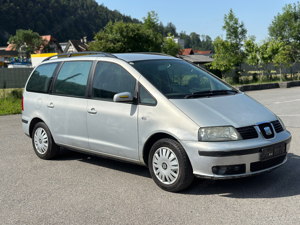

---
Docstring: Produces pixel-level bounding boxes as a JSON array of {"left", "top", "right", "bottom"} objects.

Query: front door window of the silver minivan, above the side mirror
[{"left": 93, "top": 62, "right": 135, "bottom": 101}]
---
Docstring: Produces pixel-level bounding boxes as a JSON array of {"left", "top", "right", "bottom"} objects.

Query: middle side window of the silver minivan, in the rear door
[{"left": 53, "top": 61, "right": 92, "bottom": 97}]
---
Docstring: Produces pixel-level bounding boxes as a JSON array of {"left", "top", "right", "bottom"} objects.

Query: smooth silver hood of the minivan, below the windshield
[{"left": 170, "top": 93, "right": 277, "bottom": 127}]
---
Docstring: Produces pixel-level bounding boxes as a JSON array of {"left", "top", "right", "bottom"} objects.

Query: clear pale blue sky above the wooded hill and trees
[{"left": 96, "top": 0, "right": 297, "bottom": 42}]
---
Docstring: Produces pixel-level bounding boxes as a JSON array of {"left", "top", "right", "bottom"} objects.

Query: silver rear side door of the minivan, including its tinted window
[{"left": 47, "top": 61, "right": 92, "bottom": 149}]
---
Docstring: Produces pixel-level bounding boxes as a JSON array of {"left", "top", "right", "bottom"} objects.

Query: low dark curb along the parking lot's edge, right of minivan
[{"left": 236, "top": 81, "right": 300, "bottom": 91}]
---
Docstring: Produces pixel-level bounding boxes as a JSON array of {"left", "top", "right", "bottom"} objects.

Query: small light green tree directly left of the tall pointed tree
[{"left": 210, "top": 36, "right": 237, "bottom": 80}]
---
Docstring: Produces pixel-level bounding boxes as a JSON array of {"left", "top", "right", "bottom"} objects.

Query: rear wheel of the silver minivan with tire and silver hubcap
[{"left": 32, "top": 122, "right": 60, "bottom": 160}]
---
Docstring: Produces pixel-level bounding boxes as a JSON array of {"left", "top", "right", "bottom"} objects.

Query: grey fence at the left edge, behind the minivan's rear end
[{"left": 0, "top": 68, "right": 33, "bottom": 89}]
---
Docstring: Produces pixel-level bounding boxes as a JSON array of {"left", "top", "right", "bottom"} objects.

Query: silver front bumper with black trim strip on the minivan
[{"left": 181, "top": 131, "right": 291, "bottom": 179}]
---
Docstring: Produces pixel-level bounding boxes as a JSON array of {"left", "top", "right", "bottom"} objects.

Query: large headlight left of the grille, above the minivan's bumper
[{"left": 198, "top": 127, "right": 242, "bottom": 141}]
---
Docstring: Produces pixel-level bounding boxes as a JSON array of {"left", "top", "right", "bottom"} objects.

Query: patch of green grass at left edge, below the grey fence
[{"left": 0, "top": 89, "right": 22, "bottom": 116}]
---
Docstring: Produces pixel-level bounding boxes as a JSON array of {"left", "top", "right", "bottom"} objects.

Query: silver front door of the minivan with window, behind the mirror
[{"left": 87, "top": 62, "right": 139, "bottom": 160}]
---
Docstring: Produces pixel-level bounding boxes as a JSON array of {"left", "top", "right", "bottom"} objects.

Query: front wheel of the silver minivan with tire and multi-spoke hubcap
[{"left": 148, "top": 138, "right": 194, "bottom": 192}]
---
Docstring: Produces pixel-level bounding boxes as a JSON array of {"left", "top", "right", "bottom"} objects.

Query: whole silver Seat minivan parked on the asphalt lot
[{"left": 22, "top": 53, "right": 291, "bottom": 192}]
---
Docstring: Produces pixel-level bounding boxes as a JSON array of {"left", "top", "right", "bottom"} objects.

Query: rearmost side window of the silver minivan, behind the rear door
[{"left": 26, "top": 63, "right": 58, "bottom": 93}]
